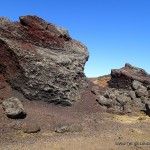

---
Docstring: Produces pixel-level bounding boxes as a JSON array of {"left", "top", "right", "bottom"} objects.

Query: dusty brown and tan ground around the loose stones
[{"left": 0, "top": 78, "right": 150, "bottom": 150}]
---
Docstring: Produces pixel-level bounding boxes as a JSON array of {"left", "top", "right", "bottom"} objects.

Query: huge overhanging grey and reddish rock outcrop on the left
[{"left": 0, "top": 16, "right": 89, "bottom": 105}]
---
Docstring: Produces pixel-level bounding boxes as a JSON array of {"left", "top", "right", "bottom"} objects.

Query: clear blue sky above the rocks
[{"left": 0, "top": 0, "right": 150, "bottom": 77}]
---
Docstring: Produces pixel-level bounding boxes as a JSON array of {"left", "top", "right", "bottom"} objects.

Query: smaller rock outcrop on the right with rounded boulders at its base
[{"left": 94, "top": 64, "right": 150, "bottom": 114}]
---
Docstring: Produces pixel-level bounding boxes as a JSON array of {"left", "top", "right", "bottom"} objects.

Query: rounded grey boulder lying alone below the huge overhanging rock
[{"left": 2, "top": 97, "right": 26, "bottom": 119}]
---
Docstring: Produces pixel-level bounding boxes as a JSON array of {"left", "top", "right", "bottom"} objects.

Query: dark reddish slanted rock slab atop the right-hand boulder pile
[{"left": 109, "top": 64, "right": 150, "bottom": 89}]
